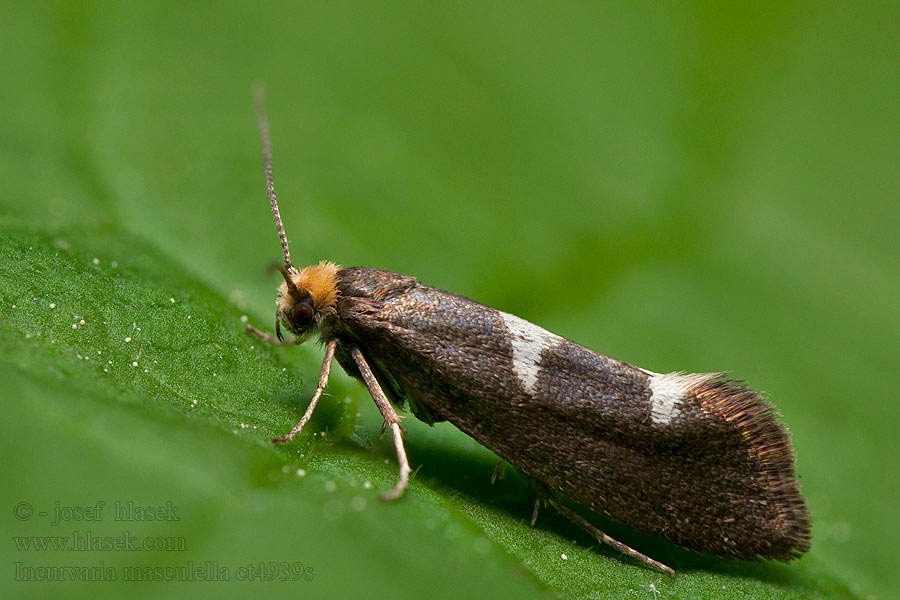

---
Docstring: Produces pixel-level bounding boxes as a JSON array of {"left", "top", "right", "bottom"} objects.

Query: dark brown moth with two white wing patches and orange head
[{"left": 248, "top": 90, "right": 810, "bottom": 575}]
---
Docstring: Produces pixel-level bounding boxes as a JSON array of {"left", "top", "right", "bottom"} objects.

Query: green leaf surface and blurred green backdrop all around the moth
[{"left": 0, "top": 1, "right": 900, "bottom": 598}]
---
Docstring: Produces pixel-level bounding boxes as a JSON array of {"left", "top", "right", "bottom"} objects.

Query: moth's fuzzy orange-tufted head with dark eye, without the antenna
[{"left": 275, "top": 261, "right": 339, "bottom": 342}]
